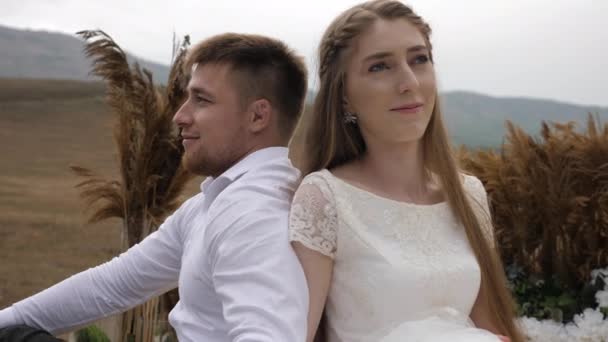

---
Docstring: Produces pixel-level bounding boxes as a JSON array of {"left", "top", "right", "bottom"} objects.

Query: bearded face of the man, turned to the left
[{"left": 173, "top": 64, "right": 247, "bottom": 177}]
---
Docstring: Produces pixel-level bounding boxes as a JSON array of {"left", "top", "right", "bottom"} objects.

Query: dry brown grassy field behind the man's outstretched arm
[{"left": 0, "top": 79, "right": 200, "bottom": 308}]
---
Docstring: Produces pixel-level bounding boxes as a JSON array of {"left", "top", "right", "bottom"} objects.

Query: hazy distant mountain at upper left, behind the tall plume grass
[{"left": 0, "top": 25, "right": 169, "bottom": 83}]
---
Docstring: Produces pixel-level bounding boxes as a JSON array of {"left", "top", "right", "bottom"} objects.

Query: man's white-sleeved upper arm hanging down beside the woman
[{"left": 208, "top": 206, "right": 308, "bottom": 342}]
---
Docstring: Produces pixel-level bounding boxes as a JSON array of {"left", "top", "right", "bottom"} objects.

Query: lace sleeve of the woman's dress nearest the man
[{"left": 289, "top": 174, "right": 338, "bottom": 259}]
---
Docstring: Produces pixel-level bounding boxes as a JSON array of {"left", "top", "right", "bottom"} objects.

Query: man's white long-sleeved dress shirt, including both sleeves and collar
[{"left": 0, "top": 147, "right": 308, "bottom": 342}]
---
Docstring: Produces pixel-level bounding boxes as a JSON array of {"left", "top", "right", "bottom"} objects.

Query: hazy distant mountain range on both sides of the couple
[{"left": 0, "top": 26, "right": 608, "bottom": 147}]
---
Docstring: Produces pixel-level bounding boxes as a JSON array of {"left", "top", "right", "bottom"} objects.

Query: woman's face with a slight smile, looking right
[{"left": 345, "top": 19, "right": 437, "bottom": 145}]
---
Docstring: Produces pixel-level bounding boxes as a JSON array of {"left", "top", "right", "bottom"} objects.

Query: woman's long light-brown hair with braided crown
[{"left": 302, "top": 0, "right": 523, "bottom": 342}]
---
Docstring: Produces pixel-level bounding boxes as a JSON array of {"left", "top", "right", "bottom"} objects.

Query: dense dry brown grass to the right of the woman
[{"left": 461, "top": 116, "right": 608, "bottom": 289}]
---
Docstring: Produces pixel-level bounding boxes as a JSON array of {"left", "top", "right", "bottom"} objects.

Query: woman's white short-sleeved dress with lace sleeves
[{"left": 290, "top": 170, "right": 499, "bottom": 342}]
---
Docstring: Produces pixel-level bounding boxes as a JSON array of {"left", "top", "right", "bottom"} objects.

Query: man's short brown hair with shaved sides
[{"left": 185, "top": 33, "right": 308, "bottom": 140}]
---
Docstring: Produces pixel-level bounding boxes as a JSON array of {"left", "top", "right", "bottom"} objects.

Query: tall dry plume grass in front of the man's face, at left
[{"left": 64, "top": 30, "right": 192, "bottom": 342}]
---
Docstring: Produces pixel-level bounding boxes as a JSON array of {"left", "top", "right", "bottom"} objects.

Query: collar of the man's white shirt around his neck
[{"left": 201, "top": 146, "right": 289, "bottom": 194}]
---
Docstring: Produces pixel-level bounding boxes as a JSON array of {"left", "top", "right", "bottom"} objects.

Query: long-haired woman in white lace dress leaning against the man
[{"left": 290, "top": 0, "right": 523, "bottom": 342}]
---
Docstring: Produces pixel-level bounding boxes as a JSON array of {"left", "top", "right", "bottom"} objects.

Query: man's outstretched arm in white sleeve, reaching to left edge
[{"left": 0, "top": 203, "right": 190, "bottom": 334}]
